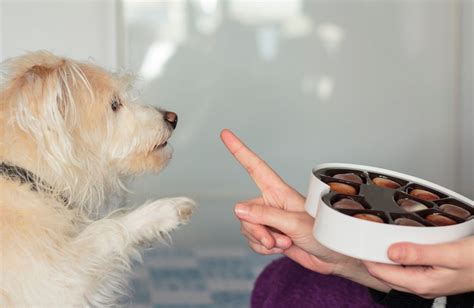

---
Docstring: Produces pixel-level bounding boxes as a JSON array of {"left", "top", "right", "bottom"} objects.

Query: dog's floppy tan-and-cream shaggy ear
[{"left": 6, "top": 53, "right": 92, "bottom": 144}]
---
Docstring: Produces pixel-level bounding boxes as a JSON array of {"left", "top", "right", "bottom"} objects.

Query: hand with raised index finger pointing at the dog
[{"left": 221, "top": 130, "right": 389, "bottom": 292}]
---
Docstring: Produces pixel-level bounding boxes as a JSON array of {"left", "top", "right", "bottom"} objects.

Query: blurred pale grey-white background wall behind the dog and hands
[{"left": 0, "top": 0, "right": 474, "bottom": 247}]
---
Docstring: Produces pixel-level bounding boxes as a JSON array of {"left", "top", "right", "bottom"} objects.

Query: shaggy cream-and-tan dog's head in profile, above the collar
[{"left": 0, "top": 52, "right": 178, "bottom": 212}]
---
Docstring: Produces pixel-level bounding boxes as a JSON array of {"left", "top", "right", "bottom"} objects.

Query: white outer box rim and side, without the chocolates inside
[{"left": 305, "top": 163, "right": 474, "bottom": 264}]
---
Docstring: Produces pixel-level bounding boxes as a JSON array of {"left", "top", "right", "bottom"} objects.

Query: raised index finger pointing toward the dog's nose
[{"left": 221, "top": 129, "right": 283, "bottom": 191}]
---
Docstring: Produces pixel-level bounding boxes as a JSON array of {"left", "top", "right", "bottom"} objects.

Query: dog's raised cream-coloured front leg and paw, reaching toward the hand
[{"left": 74, "top": 198, "right": 195, "bottom": 305}]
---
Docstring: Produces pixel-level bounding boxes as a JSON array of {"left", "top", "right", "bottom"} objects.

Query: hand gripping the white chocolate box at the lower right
[{"left": 364, "top": 236, "right": 474, "bottom": 298}]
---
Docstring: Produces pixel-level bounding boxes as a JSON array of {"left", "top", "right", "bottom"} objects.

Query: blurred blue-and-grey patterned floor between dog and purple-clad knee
[{"left": 130, "top": 247, "right": 276, "bottom": 308}]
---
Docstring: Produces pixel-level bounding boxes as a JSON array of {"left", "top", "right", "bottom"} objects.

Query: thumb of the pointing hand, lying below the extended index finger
[{"left": 235, "top": 203, "right": 313, "bottom": 237}]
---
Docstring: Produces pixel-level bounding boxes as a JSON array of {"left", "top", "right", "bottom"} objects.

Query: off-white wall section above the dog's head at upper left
[{"left": 0, "top": 0, "right": 117, "bottom": 68}]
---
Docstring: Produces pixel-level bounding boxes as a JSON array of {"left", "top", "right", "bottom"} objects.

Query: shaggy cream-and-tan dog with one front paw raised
[{"left": 0, "top": 51, "right": 195, "bottom": 307}]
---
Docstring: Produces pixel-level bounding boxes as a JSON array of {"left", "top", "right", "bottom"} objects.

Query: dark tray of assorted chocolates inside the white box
[{"left": 313, "top": 165, "right": 474, "bottom": 229}]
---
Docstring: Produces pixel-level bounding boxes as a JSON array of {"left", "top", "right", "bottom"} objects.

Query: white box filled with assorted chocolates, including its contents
[{"left": 305, "top": 163, "right": 474, "bottom": 263}]
